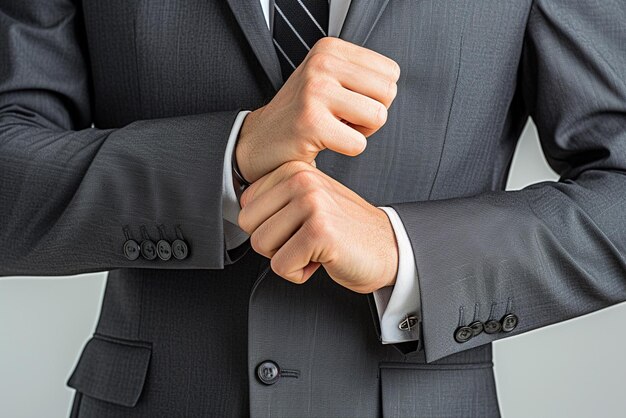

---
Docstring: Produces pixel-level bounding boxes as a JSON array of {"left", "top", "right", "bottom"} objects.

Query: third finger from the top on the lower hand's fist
[{"left": 250, "top": 201, "right": 308, "bottom": 258}]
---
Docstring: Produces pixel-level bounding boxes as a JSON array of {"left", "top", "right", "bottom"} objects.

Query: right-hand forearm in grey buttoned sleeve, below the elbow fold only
[{"left": 392, "top": 172, "right": 626, "bottom": 361}]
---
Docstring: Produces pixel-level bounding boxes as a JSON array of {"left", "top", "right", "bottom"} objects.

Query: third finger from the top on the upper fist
[{"left": 328, "top": 88, "right": 387, "bottom": 133}]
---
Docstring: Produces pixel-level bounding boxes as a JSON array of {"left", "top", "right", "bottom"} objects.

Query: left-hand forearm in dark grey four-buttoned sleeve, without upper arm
[{"left": 0, "top": 106, "right": 237, "bottom": 275}]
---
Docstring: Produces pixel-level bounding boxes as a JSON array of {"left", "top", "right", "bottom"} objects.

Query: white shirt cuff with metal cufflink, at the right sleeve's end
[{"left": 374, "top": 207, "right": 421, "bottom": 344}]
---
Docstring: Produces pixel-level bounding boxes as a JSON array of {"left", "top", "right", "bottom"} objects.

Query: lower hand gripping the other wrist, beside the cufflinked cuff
[{"left": 239, "top": 161, "right": 398, "bottom": 293}]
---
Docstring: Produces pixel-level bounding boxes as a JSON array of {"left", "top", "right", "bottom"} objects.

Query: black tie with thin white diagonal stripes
[{"left": 273, "top": 0, "right": 329, "bottom": 80}]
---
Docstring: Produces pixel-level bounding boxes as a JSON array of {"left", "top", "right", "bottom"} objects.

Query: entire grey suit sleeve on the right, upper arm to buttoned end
[{"left": 392, "top": 0, "right": 626, "bottom": 362}]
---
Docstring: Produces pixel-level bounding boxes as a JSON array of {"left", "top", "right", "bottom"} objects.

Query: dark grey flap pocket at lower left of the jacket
[{"left": 67, "top": 334, "right": 152, "bottom": 407}]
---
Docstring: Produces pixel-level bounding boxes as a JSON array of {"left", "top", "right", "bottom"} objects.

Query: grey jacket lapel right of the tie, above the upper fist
[{"left": 339, "top": 0, "right": 389, "bottom": 46}]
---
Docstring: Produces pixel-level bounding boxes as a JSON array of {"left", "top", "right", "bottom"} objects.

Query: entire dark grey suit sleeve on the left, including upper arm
[{"left": 0, "top": 0, "right": 238, "bottom": 275}]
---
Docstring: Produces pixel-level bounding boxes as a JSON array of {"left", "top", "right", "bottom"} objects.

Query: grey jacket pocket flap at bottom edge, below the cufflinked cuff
[{"left": 380, "top": 363, "right": 500, "bottom": 418}]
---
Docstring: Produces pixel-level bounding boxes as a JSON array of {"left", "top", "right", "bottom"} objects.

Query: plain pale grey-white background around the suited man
[{"left": 0, "top": 120, "right": 626, "bottom": 418}]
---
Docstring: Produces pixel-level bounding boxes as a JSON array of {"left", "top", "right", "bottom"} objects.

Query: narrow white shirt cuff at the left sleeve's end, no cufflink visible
[{"left": 222, "top": 110, "right": 250, "bottom": 250}]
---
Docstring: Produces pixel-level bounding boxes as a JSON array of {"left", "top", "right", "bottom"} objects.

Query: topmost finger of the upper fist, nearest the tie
[{"left": 305, "top": 37, "right": 400, "bottom": 82}]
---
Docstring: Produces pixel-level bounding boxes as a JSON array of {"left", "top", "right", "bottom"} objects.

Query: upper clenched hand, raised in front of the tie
[{"left": 235, "top": 38, "right": 400, "bottom": 183}]
